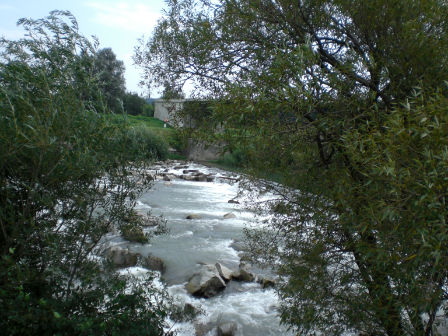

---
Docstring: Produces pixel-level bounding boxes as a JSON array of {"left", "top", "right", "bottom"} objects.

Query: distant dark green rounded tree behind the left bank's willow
[{"left": 95, "top": 48, "right": 126, "bottom": 113}]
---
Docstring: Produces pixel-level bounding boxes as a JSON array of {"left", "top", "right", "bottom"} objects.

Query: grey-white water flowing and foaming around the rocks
[{"left": 124, "top": 161, "right": 288, "bottom": 336}]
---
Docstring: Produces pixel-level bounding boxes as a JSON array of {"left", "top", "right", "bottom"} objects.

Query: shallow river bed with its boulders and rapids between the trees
[{"left": 100, "top": 161, "right": 288, "bottom": 336}]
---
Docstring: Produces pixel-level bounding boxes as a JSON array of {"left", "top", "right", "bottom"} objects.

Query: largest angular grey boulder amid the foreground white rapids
[{"left": 185, "top": 265, "right": 226, "bottom": 298}]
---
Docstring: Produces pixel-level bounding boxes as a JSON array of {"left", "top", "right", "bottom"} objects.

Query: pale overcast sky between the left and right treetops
[{"left": 0, "top": 0, "right": 165, "bottom": 96}]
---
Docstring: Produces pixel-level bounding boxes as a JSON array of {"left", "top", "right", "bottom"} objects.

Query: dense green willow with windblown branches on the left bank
[{"left": 0, "top": 11, "right": 174, "bottom": 335}]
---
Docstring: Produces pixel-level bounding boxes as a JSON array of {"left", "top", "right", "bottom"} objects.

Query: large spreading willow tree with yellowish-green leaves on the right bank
[{"left": 135, "top": 0, "right": 448, "bottom": 335}]
